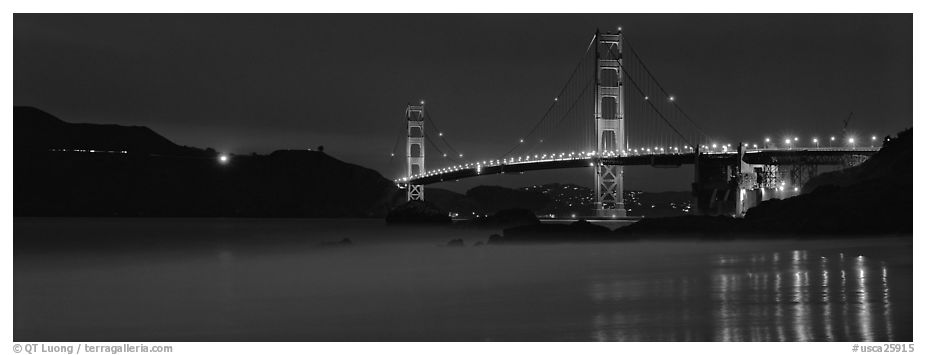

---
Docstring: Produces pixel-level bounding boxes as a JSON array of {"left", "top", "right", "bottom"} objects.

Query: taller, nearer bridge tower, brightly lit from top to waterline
[{"left": 595, "top": 27, "right": 627, "bottom": 217}]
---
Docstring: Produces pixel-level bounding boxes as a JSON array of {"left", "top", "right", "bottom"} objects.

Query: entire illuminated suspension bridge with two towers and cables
[{"left": 392, "top": 28, "right": 880, "bottom": 218}]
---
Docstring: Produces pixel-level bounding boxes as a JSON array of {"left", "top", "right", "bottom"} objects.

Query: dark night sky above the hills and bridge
[{"left": 13, "top": 14, "right": 913, "bottom": 191}]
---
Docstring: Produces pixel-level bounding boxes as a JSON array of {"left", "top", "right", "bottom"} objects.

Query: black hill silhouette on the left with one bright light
[{"left": 13, "top": 107, "right": 403, "bottom": 217}]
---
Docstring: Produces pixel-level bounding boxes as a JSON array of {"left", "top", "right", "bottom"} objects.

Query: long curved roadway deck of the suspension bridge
[{"left": 397, "top": 147, "right": 880, "bottom": 185}]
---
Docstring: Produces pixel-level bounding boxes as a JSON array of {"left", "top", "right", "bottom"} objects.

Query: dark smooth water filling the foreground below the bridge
[{"left": 13, "top": 218, "right": 913, "bottom": 342}]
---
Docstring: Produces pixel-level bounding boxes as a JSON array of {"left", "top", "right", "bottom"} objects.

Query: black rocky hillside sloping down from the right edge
[{"left": 618, "top": 128, "right": 913, "bottom": 235}]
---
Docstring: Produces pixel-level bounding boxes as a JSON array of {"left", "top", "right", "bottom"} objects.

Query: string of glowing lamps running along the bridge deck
[{"left": 394, "top": 132, "right": 878, "bottom": 182}]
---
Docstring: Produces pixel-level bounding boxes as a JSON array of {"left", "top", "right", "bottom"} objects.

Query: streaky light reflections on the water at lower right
[{"left": 589, "top": 250, "right": 896, "bottom": 342}]
